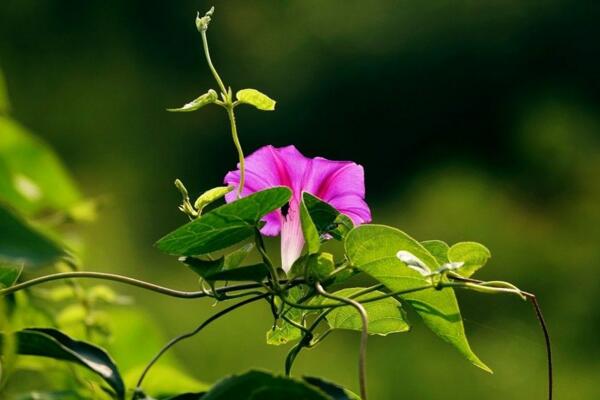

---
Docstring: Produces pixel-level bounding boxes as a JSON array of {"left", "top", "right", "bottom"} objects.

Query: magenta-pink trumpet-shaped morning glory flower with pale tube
[{"left": 225, "top": 146, "right": 371, "bottom": 272}]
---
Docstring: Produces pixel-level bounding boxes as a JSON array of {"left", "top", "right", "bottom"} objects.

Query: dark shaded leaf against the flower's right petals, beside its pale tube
[{"left": 302, "top": 192, "right": 353, "bottom": 240}]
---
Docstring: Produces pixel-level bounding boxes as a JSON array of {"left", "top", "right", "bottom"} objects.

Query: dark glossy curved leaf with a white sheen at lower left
[{"left": 0, "top": 328, "right": 125, "bottom": 399}]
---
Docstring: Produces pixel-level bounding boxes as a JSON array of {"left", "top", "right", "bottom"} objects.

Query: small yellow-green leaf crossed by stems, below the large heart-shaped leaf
[{"left": 315, "top": 288, "right": 410, "bottom": 336}]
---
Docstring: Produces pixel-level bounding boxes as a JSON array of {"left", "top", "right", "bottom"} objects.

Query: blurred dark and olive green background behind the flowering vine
[{"left": 0, "top": 0, "right": 600, "bottom": 399}]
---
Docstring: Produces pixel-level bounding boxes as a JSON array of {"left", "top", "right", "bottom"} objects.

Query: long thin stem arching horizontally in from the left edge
[{"left": 0, "top": 271, "right": 274, "bottom": 299}]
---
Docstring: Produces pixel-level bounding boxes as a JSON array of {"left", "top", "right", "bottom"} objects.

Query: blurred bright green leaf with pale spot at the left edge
[{"left": 0, "top": 116, "right": 81, "bottom": 215}]
